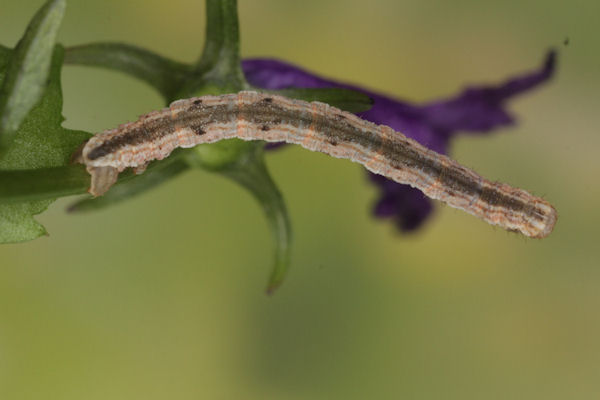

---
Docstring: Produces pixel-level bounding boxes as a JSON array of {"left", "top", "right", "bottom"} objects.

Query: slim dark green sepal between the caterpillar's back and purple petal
[{"left": 268, "top": 88, "right": 373, "bottom": 113}]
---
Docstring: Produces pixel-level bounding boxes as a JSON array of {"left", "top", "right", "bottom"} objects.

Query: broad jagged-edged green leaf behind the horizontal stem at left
[{"left": 0, "top": 46, "right": 91, "bottom": 243}]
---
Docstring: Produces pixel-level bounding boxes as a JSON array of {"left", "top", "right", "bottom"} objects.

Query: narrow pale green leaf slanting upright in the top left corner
[{"left": 0, "top": 0, "right": 65, "bottom": 150}]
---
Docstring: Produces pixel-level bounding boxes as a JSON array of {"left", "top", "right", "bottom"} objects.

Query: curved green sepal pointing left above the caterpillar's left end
[{"left": 65, "top": 43, "right": 192, "bottom": 103}]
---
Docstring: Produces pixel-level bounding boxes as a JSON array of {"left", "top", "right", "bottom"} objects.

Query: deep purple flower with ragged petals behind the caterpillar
[{"left": 242, "top": 51, "right": 556, "bottom": 232}]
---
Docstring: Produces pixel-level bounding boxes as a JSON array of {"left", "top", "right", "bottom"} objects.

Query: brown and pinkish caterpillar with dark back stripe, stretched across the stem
[{"left": 79, "top": 92, "right": 557, "bottom": 238}]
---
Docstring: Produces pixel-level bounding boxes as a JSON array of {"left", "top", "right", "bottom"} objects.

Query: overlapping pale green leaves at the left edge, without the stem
[{"left": 0, "top": 0, "right": 89, "bottom": 243}]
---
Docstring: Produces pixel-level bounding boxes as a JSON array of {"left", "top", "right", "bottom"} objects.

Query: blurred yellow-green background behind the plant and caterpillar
[{"left": 0, "top": 0, "right": 600, "bottom": 400}]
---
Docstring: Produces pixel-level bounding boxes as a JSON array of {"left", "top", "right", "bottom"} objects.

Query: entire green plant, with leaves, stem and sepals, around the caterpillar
[{"left": 0, "top": 0, "right": 371, "bottom": 292}]
